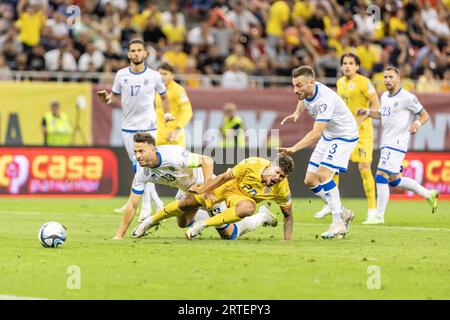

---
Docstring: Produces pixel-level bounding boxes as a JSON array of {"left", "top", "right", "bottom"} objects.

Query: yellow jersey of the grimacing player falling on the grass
[{"left": 227, "top": 157, "right": 291, "bottom": 209}]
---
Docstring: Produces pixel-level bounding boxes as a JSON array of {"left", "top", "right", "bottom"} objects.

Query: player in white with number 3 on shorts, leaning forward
[{"left": 279, "top": 66, "right": 358, "bottom": 239}]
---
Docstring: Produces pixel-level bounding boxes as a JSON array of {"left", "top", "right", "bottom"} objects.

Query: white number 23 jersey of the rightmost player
[{"left": 381, "top": 88, "right": 423, "bottom": 152}]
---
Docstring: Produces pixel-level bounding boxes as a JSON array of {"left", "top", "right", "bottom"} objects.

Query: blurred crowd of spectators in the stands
[{"left": 0, "top": 0, "right": 450, "bottom": 92}]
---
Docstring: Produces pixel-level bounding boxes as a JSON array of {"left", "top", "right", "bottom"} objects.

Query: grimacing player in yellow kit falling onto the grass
[{"left": 132, "top": 155, "right": 294, "bottom": 240}]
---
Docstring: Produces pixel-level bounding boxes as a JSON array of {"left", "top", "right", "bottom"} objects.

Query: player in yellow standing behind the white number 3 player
[{"left": 314, "top": 53, "right": 380, "bottom": 220}]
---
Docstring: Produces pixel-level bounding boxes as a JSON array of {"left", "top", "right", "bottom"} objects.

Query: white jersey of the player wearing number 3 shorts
[{"left": 303, "top": 81, "right": 358, "bottom": 141}]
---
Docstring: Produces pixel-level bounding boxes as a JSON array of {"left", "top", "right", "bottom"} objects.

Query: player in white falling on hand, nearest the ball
[{"left": 114, "top": 132, "right": 277, "bottom": 240}]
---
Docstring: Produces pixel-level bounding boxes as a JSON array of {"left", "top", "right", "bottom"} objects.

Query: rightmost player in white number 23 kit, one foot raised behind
[{"left": 358, "top": 66, "right": 439, "bottom": 224}]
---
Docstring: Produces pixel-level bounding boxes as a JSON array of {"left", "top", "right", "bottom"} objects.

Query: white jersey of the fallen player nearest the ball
[{"left": 132, "top": 145, "right": 203, "bottom": 194}]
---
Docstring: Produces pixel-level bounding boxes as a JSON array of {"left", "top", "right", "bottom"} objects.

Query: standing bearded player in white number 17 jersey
[{"left": 97, "top": 39, "right": 175, "bottom": 220}]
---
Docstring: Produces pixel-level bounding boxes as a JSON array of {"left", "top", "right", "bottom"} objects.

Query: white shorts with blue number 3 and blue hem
[{"left": 307, "top": 137, "right": 358, "bottom": 173}]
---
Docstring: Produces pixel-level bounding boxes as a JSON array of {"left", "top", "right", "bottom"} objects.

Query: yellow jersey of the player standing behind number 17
[{"left": 155, "top": 81, "right": 192, "bottom": 147}]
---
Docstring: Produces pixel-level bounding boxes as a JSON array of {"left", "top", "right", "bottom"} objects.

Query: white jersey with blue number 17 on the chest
[{"left": 112, "top": 67, "right": 166, "bottom": 132}]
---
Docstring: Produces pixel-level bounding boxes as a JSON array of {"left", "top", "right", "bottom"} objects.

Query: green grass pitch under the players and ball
[{"left": 0, "top": 198, "right": 450, "bottom": 299}]
